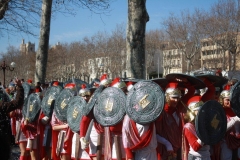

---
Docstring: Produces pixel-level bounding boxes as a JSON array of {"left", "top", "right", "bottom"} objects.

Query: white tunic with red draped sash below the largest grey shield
[{"left": 122, "top": 115, "right": 157, "bottom": 160}]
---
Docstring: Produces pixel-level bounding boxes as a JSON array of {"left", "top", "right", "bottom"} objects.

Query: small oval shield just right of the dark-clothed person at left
[{"left": 23, "top": 93, "right": 41, "bottom": 122}]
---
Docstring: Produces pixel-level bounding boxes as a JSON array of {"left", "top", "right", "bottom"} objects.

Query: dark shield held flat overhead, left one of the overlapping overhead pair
[{"left": 166, "top": 73, "right": 206, "bottom": 89}]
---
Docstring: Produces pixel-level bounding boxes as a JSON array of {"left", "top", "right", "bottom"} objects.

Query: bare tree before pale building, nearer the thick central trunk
[{"left": 163, "top": 10, "right": 202, "bottom": 73}]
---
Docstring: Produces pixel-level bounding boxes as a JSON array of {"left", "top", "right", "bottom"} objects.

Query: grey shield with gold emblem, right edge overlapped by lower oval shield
[{"left": 54, "top": 88, "right": 74, "bottom": 122}]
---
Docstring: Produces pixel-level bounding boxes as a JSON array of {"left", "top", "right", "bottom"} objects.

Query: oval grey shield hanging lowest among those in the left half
[{"left": 67, "top": 96, "right": 86, "bottom": 132}]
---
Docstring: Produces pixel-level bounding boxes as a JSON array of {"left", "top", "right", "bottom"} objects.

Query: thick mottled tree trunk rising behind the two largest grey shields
[{"left": 126, "top": 0, "right": 149, "bottom": 79}]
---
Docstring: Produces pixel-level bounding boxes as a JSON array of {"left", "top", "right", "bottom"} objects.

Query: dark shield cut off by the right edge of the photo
[{"left": 230, "top": 81, "right": 240, "bottom": 117}]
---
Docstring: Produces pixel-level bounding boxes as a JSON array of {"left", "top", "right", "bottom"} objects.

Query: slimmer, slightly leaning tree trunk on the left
[{"left": 35, "top": 0, "right": 52, "bottom": 83}]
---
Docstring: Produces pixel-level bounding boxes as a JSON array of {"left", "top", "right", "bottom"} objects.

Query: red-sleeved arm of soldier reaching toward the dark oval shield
[{"left": 184, "top": 126, "right": 204, "bottom": 152}]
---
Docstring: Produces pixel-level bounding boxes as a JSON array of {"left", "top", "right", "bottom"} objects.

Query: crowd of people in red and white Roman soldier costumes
[{"left": 0, "top": 72, "right": 240, "bottom": 160}]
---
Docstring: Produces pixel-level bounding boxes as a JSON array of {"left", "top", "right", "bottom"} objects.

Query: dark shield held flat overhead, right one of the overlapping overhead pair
[{"left": 196, "top": 74, "right": 228, "bottom": 87}]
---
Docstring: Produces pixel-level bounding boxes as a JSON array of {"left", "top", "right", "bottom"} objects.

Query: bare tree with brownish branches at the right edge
[{"left": 201, "top": 0, "right": 240, "bottom": 71}]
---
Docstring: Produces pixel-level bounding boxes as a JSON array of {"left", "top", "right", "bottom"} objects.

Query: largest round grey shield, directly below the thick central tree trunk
[{"left": 125, "top": 81, "right": 165, "bottom": 124}]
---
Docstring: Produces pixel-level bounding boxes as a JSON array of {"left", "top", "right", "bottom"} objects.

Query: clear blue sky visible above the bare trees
[{"left": 0, "top": 0, "right": 217, "bottom": 53}]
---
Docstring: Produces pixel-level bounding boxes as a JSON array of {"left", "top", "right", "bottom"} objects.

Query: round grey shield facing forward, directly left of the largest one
[{"left": 93, "top": 87, "right": 126, "bottom": 126}]
